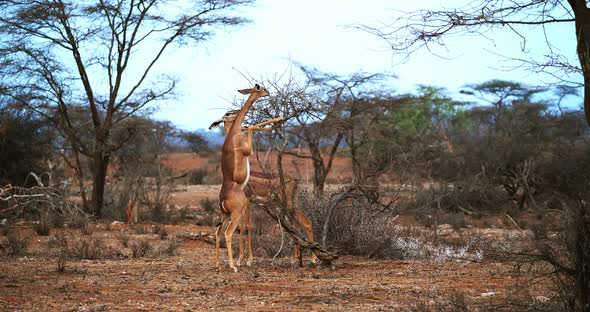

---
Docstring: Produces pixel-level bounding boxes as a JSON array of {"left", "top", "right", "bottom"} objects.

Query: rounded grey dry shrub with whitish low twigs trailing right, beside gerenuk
[{"left": 300, "top": 189, "right": 483, "bottom": 262}]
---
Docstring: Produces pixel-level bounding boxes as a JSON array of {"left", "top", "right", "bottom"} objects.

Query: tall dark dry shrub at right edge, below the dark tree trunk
[{"left": 486, "top": 145, "right": 590, "bottom": 311}]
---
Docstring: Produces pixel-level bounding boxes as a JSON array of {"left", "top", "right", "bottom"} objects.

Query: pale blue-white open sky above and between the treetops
[{"left": 150, "top": 0, "right": 581, "bottom": 131}]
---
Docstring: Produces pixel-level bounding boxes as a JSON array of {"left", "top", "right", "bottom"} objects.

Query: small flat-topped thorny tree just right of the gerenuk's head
[{"left": 255, "top": 65, "right": 388, "bottom": 194}]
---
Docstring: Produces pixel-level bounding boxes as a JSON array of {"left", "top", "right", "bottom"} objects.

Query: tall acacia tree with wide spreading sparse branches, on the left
[{"left": 0, "top": 0, "right": 254, "bottom": 216}]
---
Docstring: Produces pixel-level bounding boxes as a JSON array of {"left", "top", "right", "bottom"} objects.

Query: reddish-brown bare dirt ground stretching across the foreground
[{"left": 0, "top": 224, "right": 550, "bottom": 311}]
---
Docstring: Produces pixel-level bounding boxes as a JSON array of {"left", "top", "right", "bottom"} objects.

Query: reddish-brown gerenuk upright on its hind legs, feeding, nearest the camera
[{"left": 215, "top": 84, "right": 269, "bottom": 272}]
